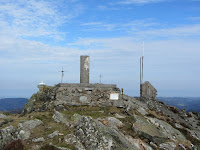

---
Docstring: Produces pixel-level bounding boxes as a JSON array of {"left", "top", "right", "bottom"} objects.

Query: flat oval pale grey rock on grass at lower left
[{"left": 18, "top": 119, "right": 43, "bottom": 131}]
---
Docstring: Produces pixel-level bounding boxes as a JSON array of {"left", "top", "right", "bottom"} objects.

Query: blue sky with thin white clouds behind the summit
[{"left": 0, "top": 0, "right": 200, "bottom": 97}]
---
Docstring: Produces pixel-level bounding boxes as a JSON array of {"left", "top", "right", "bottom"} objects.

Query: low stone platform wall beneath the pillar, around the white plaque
[{"left": 54, "top": 83, "right": 122, "bottom": 106}]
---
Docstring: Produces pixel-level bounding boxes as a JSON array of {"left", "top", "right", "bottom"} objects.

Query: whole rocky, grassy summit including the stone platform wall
[{"left": 0, "top": 83, "right": 200, "bottom": 150}]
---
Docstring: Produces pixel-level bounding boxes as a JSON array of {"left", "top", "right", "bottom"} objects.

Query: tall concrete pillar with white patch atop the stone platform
[{"left": 80, "top": 56, "right": 90, "bottom": 83}]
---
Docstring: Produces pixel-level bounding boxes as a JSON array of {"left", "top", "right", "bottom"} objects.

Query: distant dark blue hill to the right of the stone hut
[{"left": 158, "top": 97, "right": 200, "bottom": 114}]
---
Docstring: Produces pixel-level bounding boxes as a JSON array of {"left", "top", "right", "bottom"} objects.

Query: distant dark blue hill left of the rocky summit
[{"left": 0, "top": 98, "right": 28, "bottom": 111}]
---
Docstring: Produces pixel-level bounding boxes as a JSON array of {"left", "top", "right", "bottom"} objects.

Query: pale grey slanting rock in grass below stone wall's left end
[{"left": 52, "top": 110, "right": 69, "bottom": 126}]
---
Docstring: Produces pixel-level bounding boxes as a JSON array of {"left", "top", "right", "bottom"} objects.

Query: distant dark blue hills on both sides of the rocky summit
[{"left": 0, "top": 97, "right": 200, "bottom": 114}]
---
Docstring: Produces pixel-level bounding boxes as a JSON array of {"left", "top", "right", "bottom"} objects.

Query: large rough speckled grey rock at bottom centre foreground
[{"left": 75, "top": 116, "right": 137, "bottom": 150}]
